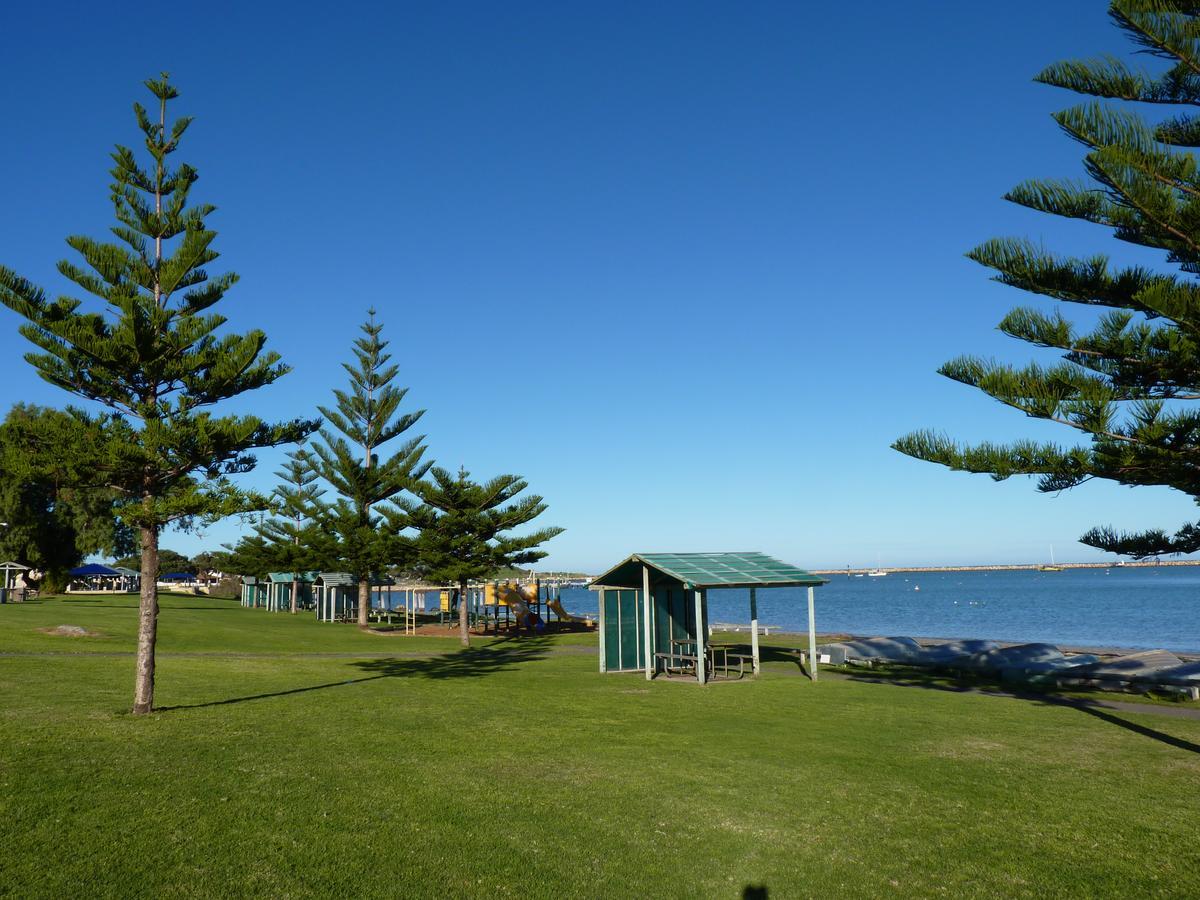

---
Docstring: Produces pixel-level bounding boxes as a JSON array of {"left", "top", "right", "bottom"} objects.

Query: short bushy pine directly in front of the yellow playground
[{"left": 400, "top": 466, "right": 563, "bottom": 647}]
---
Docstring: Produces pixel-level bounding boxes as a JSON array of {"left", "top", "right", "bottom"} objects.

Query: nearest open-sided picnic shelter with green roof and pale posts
[{"left": 589, "top": 553, "right": 828, "bottom": 684}]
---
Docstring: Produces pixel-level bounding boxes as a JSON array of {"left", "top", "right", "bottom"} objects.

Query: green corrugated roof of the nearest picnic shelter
[{"left": 592, "top": 552, "right": 829, "bottom": 588}]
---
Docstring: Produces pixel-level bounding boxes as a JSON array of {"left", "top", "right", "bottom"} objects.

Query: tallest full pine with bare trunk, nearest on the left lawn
[{"left": 0, "top": 73, "right": 317, "bottom": 714}]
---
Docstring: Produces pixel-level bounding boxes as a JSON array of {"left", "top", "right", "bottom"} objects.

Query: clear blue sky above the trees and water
[{"left": 0, "top": 0, "right": 1195, "bottom": 570}]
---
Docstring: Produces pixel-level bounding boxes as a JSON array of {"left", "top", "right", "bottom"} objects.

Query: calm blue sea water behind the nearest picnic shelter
[{"left": 563, "top": 566, "right": 1200, "bottom": 652}]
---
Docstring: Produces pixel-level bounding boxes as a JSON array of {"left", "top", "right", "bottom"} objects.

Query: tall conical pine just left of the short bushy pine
[{"left": 313, "top": 310, "right": 430, "bottom": 628}]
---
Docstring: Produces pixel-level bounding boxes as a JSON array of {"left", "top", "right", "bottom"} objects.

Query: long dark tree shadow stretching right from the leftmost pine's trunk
[{"left": 156, "top": 637, "right": 550, "bottom": 713}]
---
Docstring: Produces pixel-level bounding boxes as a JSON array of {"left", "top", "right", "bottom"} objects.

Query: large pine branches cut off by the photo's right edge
[{"left": 893, "top": 0, "right": 1200, "bottom": 558}]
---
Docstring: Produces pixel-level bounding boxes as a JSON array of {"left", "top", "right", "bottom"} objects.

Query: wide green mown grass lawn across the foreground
[{"left": 0, "top": 596, "right": 1200, "bottom": 898}]
